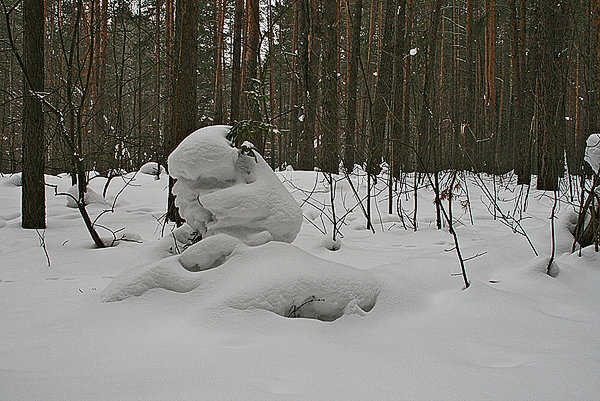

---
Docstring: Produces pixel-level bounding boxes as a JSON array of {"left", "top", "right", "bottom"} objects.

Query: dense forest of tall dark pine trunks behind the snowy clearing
[{"left": 0, "top": 0, "right": 600, "bottom": 189}]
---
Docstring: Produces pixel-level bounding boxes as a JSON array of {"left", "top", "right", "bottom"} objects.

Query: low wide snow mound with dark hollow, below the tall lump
[{"left": 101, "top": 238, "right": 381, "bottom": 321}]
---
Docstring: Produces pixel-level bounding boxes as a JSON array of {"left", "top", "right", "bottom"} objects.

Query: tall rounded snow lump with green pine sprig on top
[{"left": 168, "top": 125, "right": 302, "bottom": 245}]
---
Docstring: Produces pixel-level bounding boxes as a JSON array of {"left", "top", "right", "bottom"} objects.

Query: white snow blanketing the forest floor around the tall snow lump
[{"left": 0, "top": 164, "right": 600, "bottom": 400}]
